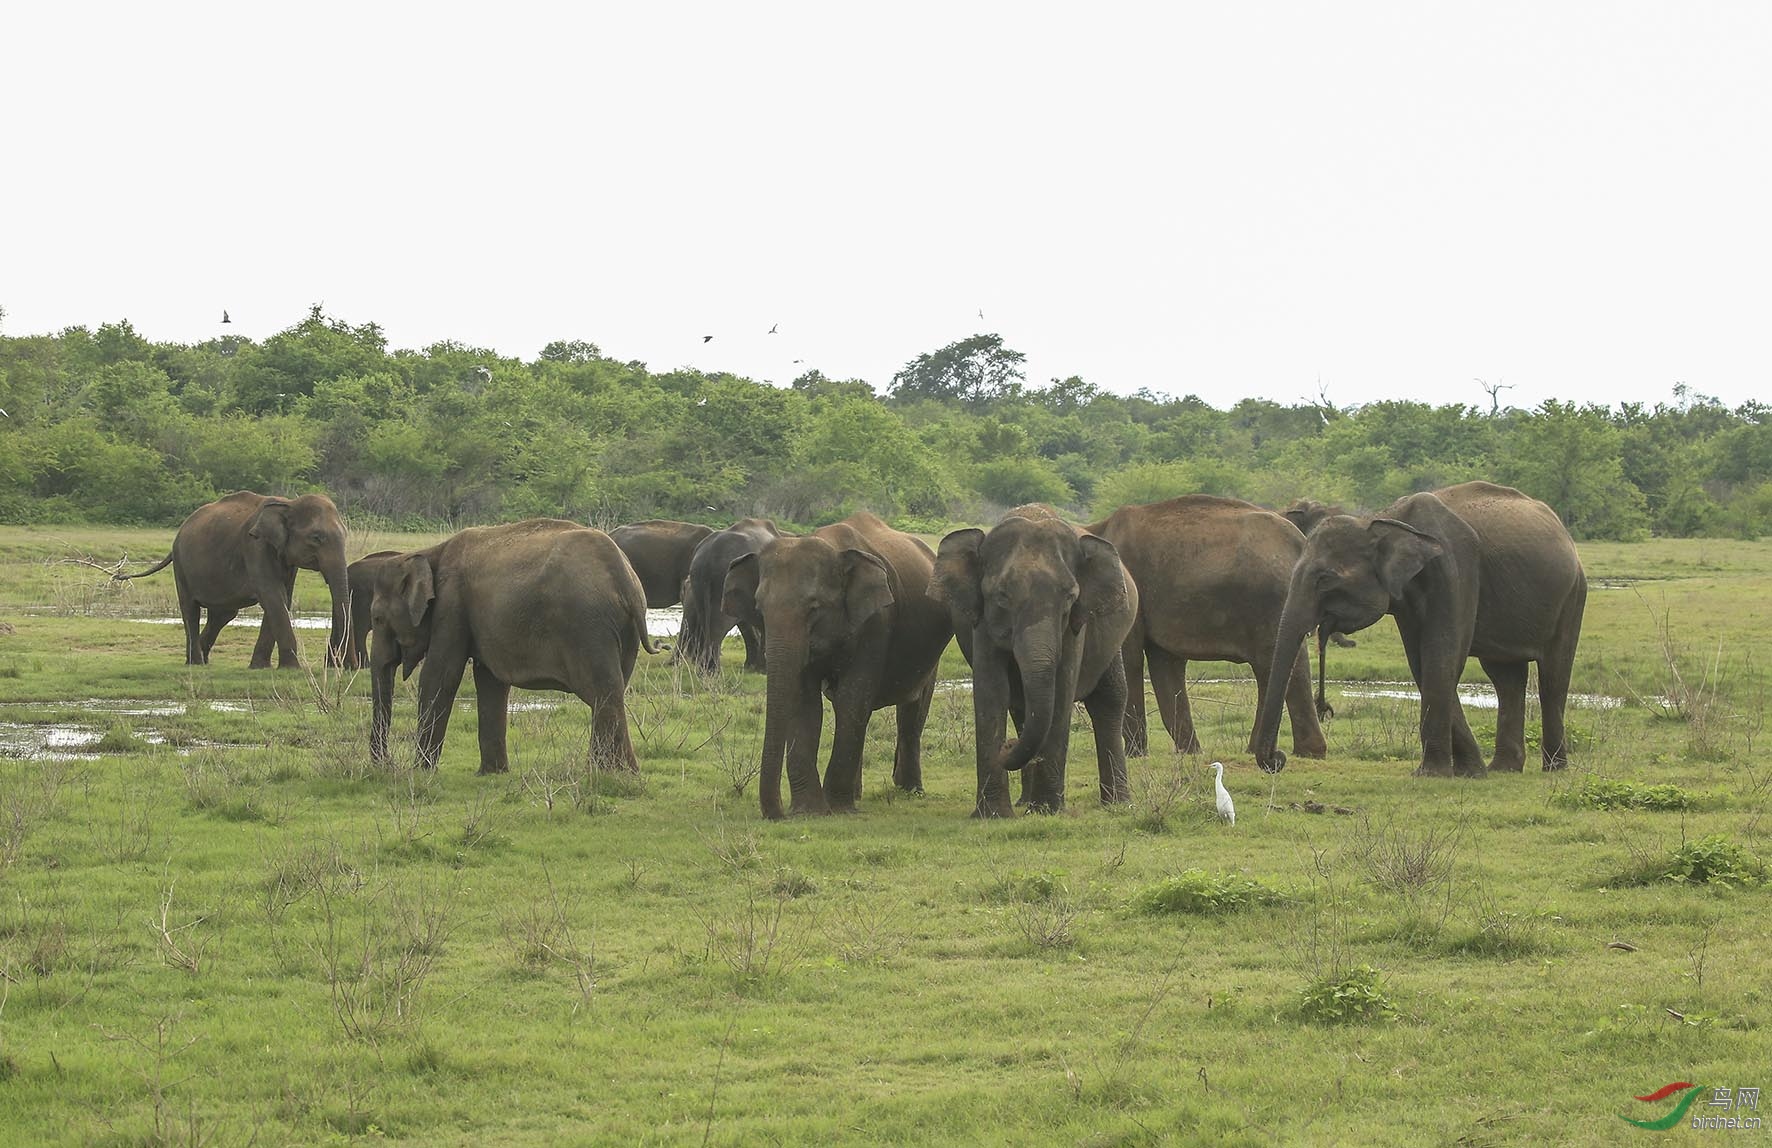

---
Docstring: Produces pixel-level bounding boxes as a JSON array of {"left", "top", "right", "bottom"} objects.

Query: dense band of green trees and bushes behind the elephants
[{"left": 0, "top": 306, "right": 1772, "bottom": 539}]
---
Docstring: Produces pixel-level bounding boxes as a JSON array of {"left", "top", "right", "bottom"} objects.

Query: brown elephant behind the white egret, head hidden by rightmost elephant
[{"left": 1084, "top": 494, "right": 1327, "bottom": 756}]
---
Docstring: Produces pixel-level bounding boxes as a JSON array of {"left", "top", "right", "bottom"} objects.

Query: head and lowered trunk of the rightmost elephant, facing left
[{"left": 1255, "top": 514, "right": 1446, "bottom": 772}]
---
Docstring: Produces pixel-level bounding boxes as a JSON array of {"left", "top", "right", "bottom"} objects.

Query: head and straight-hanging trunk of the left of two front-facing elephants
[{"left": 721, "top": 537, "right": 895, "bottom": 818}]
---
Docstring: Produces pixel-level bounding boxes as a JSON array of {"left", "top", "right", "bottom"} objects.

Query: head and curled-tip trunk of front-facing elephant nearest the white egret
[{"left": 930, "top": 512, "right": 1127, "bottom": 792}]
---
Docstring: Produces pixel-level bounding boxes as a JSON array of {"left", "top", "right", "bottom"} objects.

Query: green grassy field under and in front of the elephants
[{"left": 0, "top": 528, "right": 1772, "bottom": 1144}]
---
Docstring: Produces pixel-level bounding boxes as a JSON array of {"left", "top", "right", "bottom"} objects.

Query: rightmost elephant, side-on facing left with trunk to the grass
[{"left": 1255, "top": 482, "right": 1588, "bottom": 778}]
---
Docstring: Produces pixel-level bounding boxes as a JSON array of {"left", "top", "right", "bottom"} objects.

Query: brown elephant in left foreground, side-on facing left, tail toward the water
[{"left": 369, "top": 519, "right": 657, "bottom": 772}]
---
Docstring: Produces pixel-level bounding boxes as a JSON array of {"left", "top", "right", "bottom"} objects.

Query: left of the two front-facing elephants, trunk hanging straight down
[{"left": 721, "top": 510, "right": 953, "bottom": 818}]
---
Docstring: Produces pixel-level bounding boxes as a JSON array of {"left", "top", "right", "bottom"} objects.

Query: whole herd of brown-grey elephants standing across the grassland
[{"left": 119, "top": 482, "right": 1588, "bottom": 817}]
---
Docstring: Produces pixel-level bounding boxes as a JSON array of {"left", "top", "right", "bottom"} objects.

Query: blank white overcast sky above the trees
[{"left": 0, "top": 0, "right": 1772, "bottom": 406}]
